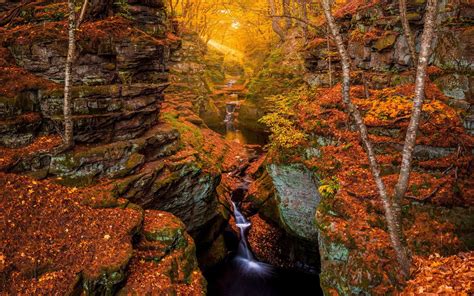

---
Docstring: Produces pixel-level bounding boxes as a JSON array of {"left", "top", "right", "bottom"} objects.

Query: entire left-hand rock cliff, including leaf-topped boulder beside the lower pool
[{"left": 0, "top": 0, "right": 244, "bottom": 295}]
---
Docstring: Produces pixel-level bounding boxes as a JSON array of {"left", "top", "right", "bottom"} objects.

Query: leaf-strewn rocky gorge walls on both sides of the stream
[{"left": 0, "top": 0, "right": 474, "bottom": 295}]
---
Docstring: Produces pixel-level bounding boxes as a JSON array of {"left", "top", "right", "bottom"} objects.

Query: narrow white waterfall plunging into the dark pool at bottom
[{"left": 232, "top": 202, "right": 272, "bottom": 276}]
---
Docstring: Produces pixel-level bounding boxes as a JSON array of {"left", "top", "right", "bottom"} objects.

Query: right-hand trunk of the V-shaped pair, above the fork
[{"left": 395, "top": 0, "right": 438, "bottom": 211}]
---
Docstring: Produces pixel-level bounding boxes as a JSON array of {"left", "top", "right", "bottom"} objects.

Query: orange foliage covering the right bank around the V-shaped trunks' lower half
[{"left": 286, "top": 83, "right": 474, "bottom": 294}]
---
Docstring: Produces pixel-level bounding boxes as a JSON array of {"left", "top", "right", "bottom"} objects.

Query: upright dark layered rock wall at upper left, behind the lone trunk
[{"left": 0, "top": 1, "right": 178, "bottom": 147}]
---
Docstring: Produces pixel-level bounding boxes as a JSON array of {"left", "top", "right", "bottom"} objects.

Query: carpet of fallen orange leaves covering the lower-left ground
[{"left": 0, "top": 173, "right": 142, "bottom": 295}]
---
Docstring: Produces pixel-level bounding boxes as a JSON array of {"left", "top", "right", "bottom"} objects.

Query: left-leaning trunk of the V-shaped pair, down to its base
[{"left": 321, "top": 0, "right": 410, "bottom": 277}]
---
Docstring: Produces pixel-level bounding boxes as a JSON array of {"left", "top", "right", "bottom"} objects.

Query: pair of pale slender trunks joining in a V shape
[{"left": 321, "top": 0, "right": 437, "bottom": 278}]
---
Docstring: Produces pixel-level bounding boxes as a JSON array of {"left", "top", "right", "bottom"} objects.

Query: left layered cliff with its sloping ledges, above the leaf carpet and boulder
[{"left": 0, "top": 0, "right": 223, "bottom": 256}]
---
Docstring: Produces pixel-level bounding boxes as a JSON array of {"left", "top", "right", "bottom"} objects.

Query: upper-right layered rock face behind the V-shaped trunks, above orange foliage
[{"left": 305, "top": 0, "right": 474, "bottom": 134}]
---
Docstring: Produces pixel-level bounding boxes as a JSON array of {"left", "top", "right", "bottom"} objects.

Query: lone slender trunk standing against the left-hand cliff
[{"left": 64, "top": 0, "right": 76, "bottom": 148}]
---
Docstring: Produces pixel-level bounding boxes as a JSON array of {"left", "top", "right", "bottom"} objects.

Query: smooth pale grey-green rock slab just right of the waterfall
[{"left": 268, "top": 164, "right": 320, "bottom": 241}]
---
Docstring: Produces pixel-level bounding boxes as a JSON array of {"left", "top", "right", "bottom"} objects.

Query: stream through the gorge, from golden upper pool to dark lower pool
[{"left": 205, "top": 80, "right": 323, "bottom": 296}]
